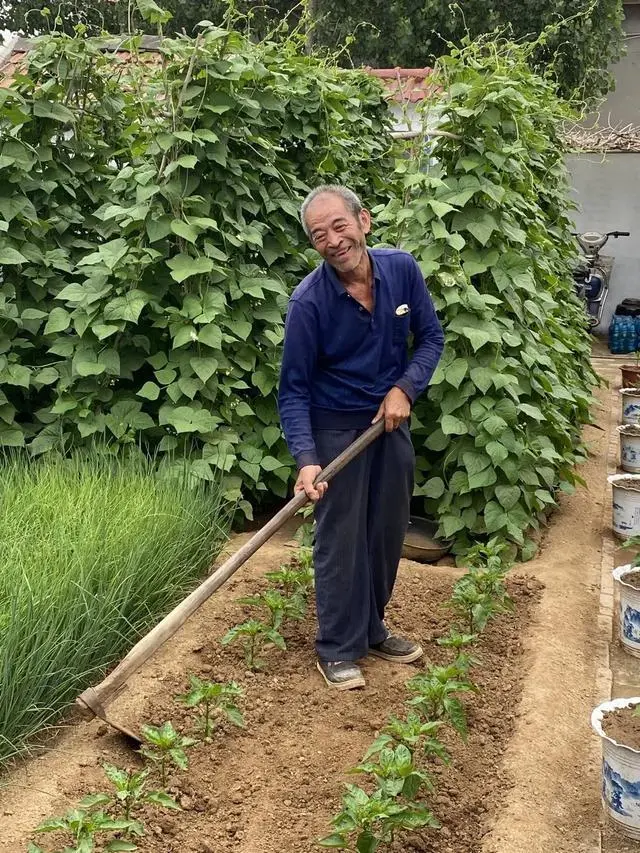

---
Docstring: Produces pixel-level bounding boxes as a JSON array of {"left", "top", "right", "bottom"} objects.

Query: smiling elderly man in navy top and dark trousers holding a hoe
[{"left": 279, "top": 186, "right": 444, "bottom": 690}]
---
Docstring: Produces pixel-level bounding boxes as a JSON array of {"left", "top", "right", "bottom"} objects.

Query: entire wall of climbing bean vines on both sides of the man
[{"left": 0, "top": 28, "right": 594, "bottom": 556}]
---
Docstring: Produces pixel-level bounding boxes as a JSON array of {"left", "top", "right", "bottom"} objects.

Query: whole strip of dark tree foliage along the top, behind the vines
[{"left": 0, "top": 0, "right": 624, "bottom": 101}]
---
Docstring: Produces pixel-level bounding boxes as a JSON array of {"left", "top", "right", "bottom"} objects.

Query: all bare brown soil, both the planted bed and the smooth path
[{"left": 0, "top": 366, "right": 614, "bottom": 853}]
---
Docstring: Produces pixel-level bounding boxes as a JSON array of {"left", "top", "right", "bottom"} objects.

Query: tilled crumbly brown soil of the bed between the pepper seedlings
[{"left": 16, "top": 563, "right": 542, "bottom": 853}]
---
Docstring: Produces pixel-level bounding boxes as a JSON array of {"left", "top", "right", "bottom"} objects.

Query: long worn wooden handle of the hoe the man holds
[{"left": 76, "top": 419, "right": 384, "bottom": 716}]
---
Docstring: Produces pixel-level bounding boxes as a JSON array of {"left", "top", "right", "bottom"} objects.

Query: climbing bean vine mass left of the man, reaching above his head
[{"left": 0, "top": 28, "right": 393, "bottom": 513}]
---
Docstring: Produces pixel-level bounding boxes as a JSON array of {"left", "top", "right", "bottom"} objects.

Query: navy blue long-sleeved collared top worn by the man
[{"left": 279, "top": 249, "right": 444, "bottom": 468}]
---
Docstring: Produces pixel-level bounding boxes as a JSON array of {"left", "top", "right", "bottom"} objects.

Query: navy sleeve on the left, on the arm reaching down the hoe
[{"left": 278, "top": 299, "right": 320, "bottom": 468}]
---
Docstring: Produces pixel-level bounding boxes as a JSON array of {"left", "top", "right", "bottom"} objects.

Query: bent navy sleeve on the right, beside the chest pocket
[{"left": 395, "top": 257, "right": 444, "bottom": 403}]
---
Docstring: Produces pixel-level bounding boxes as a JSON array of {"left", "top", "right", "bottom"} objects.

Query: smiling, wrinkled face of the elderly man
[{"left": 305, "top": 193, "right": 371, "bottom": 273}]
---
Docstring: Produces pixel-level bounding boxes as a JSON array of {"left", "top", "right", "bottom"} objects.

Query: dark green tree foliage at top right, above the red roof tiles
[{"left": 317, "top": 0, "right": 624, "bottom": 99}]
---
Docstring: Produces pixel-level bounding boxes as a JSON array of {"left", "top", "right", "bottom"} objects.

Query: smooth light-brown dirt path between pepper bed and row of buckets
[{"left": 484, "top": 362, "right": 617, "bottom": 853}]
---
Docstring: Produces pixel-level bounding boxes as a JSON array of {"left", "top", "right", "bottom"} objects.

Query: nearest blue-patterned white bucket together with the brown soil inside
[{"left": 591, "top": 696, "right": 640, "bottom": 840}]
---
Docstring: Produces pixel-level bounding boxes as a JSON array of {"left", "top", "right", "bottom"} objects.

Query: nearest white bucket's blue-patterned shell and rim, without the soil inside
[{"left": 591, "top": 696, "right": 640, "bottom": 839}]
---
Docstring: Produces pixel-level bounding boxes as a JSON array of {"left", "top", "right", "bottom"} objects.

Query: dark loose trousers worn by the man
[{"left": 314, "top": 423, "right": 415, "bottom": 661}]
